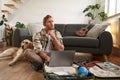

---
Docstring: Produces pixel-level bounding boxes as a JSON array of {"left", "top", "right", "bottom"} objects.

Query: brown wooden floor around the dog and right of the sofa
[{"left": 0, "top": 49, "right": 120, "bottom": 80}]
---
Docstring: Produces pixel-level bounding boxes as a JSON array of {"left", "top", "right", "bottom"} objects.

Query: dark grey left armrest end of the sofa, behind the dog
[{"left": 12, "top": 28, "right": 32, "bottom": 47}]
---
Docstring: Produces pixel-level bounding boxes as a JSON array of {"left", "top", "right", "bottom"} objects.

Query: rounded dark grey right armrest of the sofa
[{"left": 98, "top": 31, "right": 113, "bottom": 54}]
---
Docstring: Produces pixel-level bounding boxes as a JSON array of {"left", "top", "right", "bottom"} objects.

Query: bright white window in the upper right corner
[{"left": 105, "top": 0, "right": 120, "bottom": 16}]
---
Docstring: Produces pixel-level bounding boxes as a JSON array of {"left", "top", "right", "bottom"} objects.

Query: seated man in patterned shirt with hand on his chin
[{"left": 25, "top": 15, "right": 64, "bottom": 71}]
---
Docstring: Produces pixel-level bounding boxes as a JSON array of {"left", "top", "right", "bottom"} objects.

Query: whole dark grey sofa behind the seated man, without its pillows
[{"left": 12, "top": 24, "right": 112, "bottom": 55}]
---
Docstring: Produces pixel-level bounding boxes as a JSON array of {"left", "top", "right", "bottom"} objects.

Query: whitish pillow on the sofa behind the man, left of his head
[{"left": 28, "top": 23, "right": 43, "bottom": 35}]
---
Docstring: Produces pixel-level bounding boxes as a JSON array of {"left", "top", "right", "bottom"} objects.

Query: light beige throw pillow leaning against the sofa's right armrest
[{"left": 86, "top": 23, "right": 109, "bottom": 38}]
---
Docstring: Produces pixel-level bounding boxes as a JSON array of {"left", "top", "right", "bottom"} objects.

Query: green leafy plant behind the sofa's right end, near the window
[{"left": 83, "top": 4, "right": 107, "bottom": 21}]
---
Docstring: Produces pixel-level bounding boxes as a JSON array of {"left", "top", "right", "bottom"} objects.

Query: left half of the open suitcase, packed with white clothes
[{"left": 43, "top": 66, "right": 94, "bottom": 80}]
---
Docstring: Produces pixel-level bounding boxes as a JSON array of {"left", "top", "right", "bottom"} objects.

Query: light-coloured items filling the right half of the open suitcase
[{"left": 89, "top": 62, "right": 120, "bottom": 79}]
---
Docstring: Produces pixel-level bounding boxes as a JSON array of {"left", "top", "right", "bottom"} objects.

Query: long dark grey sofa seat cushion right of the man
[{"left": 63, "top": 36, "right": 99, "bottom": 48}]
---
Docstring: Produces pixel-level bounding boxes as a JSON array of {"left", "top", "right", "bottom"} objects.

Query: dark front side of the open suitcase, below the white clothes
[{"left": 43, "top": 65, "right": 94, "bottom": 80}]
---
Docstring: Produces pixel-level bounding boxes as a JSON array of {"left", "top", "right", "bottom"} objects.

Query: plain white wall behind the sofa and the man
[{"left": 9, "top": 0, "right": 102, "bottom": 24}]
